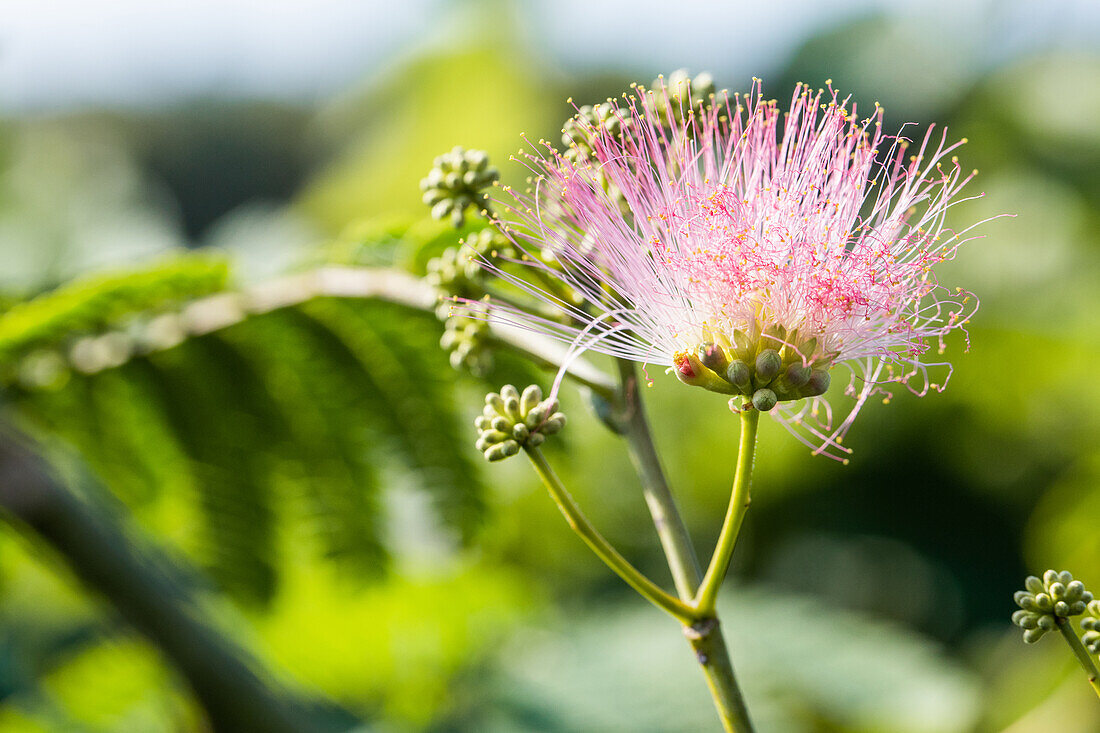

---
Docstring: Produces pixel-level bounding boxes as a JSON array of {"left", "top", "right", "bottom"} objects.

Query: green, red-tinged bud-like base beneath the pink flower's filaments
[{"left": 673, "top": 326, "right": 837, "bottom": 413}]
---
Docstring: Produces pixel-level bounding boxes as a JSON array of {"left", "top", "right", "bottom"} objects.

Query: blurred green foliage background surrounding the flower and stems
[{"left": 0, "top": 2, "right": 1100, "bottom": 733}]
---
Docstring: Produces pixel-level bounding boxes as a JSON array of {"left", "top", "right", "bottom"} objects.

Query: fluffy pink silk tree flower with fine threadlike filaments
[{"left": 468, "top": 78, "right": 977, "bottom": 459}]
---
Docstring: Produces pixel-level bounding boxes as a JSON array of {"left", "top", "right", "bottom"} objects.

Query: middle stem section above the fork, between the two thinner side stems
[{"left": 616, "top": 359, "right": 703, "bottom": 600}]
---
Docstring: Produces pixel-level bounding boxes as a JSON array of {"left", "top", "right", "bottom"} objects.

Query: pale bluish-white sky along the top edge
[{"left": 0, "top": 0, "right": 1100, "bottom": 113}]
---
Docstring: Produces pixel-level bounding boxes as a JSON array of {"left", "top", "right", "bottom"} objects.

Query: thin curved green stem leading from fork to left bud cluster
[{"left": 524, "top": 446, "right": 697, "bottom": 625}]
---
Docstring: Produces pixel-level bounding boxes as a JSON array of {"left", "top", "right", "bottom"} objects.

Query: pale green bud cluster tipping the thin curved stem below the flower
[{"left": 474, "top": 384, "right": 565, "bottom": 461}]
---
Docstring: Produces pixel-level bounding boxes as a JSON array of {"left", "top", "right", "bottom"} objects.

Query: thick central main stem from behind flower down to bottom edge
[{"left": 616, "top": 359, "right": 752, "bottom": 733}]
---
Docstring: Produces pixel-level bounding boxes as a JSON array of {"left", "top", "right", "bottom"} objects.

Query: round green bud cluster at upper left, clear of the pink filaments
[{"left": 420, "top": 145, "right": 501, "bottom": 227}]
